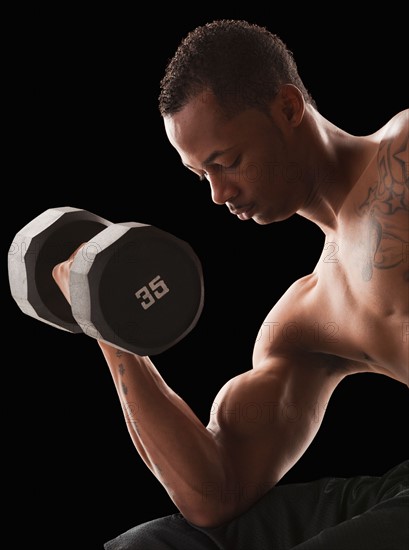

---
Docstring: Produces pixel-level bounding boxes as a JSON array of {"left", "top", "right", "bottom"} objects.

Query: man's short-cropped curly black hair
[{"left": 159, "top": 19, "right": 315, "bottom": 116}]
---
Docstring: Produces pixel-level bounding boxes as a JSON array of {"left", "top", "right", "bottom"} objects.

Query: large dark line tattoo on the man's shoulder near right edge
[{"left": 359, "top": 129, "right": 409, "bottom": 281}]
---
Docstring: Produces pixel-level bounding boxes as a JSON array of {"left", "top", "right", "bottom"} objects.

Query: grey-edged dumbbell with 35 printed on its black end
[{"left": 8, "top": 207, "right": 204, "bottom": 355}]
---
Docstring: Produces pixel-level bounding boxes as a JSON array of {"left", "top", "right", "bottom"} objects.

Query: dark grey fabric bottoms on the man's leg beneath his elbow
[{"left": 104, "top": 461, "right": 409, "bottom": 550}]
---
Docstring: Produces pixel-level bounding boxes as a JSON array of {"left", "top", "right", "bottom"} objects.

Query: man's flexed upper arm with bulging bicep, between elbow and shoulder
[{"left": 207, "top": 354, "right": 340, "bottom": 500}]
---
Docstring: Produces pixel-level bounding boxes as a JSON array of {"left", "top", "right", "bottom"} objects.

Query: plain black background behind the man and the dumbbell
[{"left": 3, "top": 5, "right": 408, "bottom": 549}]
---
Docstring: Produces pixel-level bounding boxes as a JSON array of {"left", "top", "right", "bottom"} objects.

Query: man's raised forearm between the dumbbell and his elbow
[{"left": 100, "top": 342, "right": 225, "bottom": 523}]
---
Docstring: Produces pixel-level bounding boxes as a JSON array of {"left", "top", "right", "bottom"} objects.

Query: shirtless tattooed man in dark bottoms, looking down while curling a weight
[{"left": 54, "top": 21, "right": 409, "bottom": 550}]
